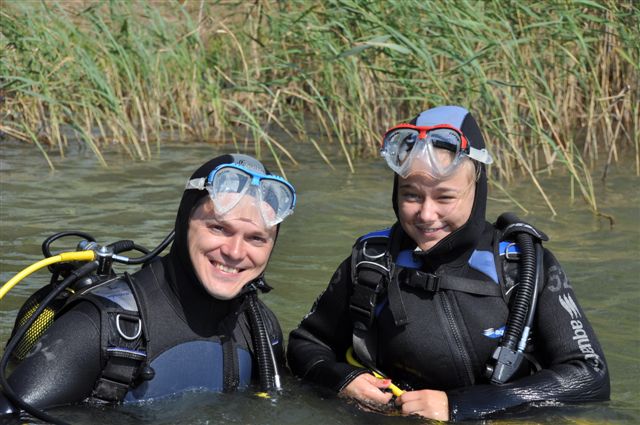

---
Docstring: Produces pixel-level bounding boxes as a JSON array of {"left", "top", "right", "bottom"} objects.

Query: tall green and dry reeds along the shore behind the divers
[{"left": 0, "top": 0, "right": 640, "bottom": 212}]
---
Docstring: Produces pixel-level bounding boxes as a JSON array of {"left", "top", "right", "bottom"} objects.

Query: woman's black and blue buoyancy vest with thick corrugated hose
[{"left": 349, "top": 213, "right": 548, "bottom": 384}]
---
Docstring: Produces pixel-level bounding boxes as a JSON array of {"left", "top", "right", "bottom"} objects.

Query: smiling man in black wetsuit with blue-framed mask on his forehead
[{"left": 0, "top": 154, "right": 296, "bottom": 414}]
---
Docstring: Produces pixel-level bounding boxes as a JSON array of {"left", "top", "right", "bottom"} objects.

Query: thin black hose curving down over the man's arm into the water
[{"left": 0, "top": 261, "right": 98, "bottom": 425}]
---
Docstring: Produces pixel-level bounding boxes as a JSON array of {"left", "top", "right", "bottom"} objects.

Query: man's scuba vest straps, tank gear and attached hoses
[{"left": 0, "top": 231, "right": 281, "bottom": 423}]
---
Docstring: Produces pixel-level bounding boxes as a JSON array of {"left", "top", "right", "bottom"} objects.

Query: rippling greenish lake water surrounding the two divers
[{"left": 0, "top": 141, "right": 640, "bottom": 424}]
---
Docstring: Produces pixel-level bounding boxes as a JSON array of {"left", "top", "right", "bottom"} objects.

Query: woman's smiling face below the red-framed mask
[{"left": 398, "top": 160, "right": 475, "bottom": 251}]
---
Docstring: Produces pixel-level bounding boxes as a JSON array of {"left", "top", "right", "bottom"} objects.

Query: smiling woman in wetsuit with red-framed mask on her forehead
[{"left": 287, "top": 106, "right": 610, "bottom": 421}]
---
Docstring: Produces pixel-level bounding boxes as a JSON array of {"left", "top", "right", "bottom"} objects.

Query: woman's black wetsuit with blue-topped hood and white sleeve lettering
[{"left": 287, "top": 107, "right": 610, "bottom": 420}]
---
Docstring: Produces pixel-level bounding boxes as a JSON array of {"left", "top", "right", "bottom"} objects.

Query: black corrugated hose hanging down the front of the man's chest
[{"left": 248, "top": 291, "right": 282, "bottom": 391}]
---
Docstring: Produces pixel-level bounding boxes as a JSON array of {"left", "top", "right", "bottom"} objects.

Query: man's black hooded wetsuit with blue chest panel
[{"left": 0, "top": 155, "right": 284, "bottom": 414}]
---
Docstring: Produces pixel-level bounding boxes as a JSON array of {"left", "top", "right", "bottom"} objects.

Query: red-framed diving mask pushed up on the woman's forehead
[{"left": 380, "top": 124, "right": 493, "bottom": 180}]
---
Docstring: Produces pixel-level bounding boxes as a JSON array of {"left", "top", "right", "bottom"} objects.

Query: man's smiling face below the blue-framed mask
[{"left": 188, "top": 197, "right": 276, "bottom": 300}]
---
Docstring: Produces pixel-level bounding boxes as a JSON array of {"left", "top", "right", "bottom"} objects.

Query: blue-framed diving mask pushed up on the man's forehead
[{"left": 186, "top": 163, "right": 296, "bottom": 227}]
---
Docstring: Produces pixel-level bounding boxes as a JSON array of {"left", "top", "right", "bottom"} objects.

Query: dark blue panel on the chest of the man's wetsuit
[{"left": 124, "top": 341, "right": 252, "bottom": 403}]
